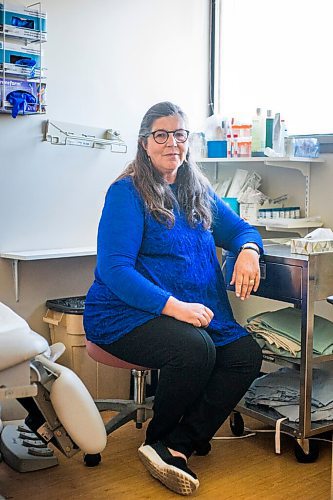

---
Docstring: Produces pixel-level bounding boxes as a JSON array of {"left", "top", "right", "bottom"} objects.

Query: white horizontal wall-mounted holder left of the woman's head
[{"left": 44, "top": 120, "right": 127, "bottom": 153}]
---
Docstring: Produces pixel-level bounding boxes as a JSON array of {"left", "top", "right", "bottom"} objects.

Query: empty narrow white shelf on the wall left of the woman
[{"left": 0, "top": 246, "right": 97, "bottom": 302}]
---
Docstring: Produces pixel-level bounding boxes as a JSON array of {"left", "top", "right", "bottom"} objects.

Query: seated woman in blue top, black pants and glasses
[{"left": 84, "top": 102, "right": 262, "bottom": 495}]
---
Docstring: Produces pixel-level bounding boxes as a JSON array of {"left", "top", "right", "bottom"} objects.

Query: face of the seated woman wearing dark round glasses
[{"left": 143, "top": 115, "right": 188, "bottom": 184}]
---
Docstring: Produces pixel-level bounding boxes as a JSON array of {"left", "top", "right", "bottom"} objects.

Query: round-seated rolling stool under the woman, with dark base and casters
[{"left": 84, "top": 340, "right": 154, "bottom": 467}]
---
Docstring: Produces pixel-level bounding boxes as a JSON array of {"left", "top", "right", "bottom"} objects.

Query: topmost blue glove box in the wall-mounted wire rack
[{"left": 0, "top": 2, "right": 47, "bottom": 42}]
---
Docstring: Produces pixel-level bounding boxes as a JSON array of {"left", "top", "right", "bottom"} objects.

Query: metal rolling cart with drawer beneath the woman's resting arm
[{"left": 223, "top": 243, "right": 333, "bottom": 461}]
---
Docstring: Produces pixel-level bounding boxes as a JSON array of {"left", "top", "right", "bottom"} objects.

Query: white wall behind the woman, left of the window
[{"left": 0, "top": 0, "right": 208, "bottom": 335}]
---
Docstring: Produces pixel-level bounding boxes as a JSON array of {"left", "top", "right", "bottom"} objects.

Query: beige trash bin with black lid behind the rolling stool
[{"left": 43, "top": 297, "right": 131, "bottom": 399}]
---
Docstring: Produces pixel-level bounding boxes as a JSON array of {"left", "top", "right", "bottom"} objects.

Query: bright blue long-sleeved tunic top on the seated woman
[{"left": 84, "top": 177, "right": 262, "bottom": 345}]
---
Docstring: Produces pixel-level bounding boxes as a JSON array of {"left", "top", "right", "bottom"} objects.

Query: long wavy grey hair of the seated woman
[{"left": 117, "top": 101, "right": 212, "bottom": 229}]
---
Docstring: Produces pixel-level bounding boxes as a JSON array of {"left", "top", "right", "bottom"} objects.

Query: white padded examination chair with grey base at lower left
[{"left": 0, "top": 302, "right": 106, "bottom": 472}]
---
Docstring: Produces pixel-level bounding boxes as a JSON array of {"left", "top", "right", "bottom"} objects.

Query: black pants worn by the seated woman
[{"left": 100, "top": 316, "right": 262, "bottom": 457}]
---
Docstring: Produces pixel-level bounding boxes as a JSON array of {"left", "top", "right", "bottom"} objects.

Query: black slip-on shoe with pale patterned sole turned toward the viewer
[{"left": 138, "top": 442, "right": 199, "bottom": 496}]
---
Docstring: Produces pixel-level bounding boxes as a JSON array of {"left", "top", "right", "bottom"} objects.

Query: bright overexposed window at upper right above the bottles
[{"left": 214, "top": 0, "right": 333, "bottom": 134}]
